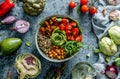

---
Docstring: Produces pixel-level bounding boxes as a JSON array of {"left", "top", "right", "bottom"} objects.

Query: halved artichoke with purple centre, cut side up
[{"left": 15, "top": 53, "right": 41, "bottom": 79}]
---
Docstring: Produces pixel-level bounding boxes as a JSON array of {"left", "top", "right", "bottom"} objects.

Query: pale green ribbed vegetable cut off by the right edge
[{"left": 108, "top": 26, "right": 120, "bottom": 45}]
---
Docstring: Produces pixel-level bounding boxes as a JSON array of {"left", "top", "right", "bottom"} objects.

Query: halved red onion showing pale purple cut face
[{"left": 11, "top": 20, "right": 30, "bottom": 33}]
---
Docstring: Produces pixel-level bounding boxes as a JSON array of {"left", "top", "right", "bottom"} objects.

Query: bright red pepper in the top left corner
[{"left": 0, "top": 0, "right": 15, "bottom": 17}]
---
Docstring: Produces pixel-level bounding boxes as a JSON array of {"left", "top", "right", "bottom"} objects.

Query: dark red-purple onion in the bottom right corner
[{"left": 105, "top": 64, "right": 118, "bottom": 79}]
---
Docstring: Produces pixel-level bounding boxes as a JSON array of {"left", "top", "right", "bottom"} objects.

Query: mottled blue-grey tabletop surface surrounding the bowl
[{"left": 0, "top": 0, "right": 98, "bottom": 79}]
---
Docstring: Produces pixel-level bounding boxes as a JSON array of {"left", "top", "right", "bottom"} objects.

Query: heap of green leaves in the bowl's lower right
[{"left": 64, "top": 41, "right": 83, "bottom": 56}]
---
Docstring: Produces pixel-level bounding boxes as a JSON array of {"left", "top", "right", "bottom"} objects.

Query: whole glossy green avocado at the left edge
[{"left": 0, "top": 37, "right": 22, "bottom": 55}]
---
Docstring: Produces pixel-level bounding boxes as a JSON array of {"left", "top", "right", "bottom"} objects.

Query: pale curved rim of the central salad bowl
[{"left": 35, "top": 15, "right": 82, "bottom": 62}]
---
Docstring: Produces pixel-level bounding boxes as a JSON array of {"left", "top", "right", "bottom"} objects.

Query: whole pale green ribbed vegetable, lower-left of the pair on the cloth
[{"left": 99, "top": 37, "right": 117, "bottom": 56}]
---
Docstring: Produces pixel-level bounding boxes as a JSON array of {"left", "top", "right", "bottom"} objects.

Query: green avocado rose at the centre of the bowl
[{"left": 50, "top": 28, "right": 67, "bottom": 46}]
